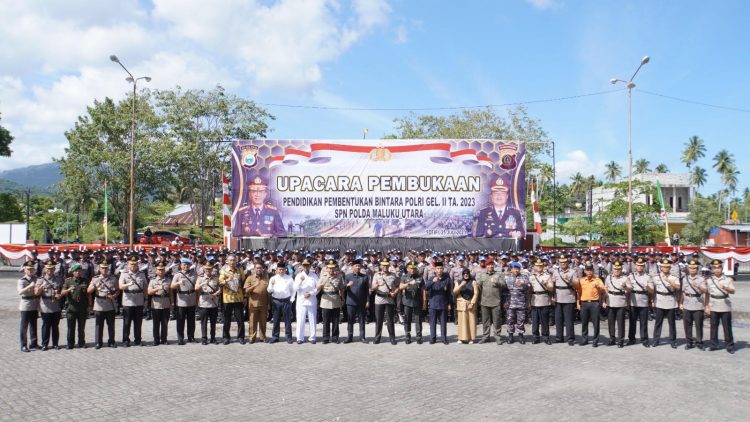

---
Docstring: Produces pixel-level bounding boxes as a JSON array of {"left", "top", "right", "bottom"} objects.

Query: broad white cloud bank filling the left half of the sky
[{"left": 0, "top": 0, "right": 391, "bottom": 169}]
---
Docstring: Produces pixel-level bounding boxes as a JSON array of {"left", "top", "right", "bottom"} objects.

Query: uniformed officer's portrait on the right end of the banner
[{"left": 474, "top": 175, "right": 524, "bottom": 239}]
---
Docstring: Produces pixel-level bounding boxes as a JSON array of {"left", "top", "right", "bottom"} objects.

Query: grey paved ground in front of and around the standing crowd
[{"left": 0, "top": 273, "right": 750, "bottom": 421}]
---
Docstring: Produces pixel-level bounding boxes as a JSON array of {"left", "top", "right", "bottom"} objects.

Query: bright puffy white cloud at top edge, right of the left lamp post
[{"left": 154, "top": 0, "right": 390, "bottom": 90}]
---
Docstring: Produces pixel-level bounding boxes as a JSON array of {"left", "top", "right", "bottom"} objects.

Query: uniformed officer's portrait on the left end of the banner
[{"left": 238, "top": 176, "right": 286, "bottom": 237}]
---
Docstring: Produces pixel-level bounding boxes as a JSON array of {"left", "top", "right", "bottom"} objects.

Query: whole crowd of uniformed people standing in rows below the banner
[{"left": 17, "top": 249, "right": 735, "bottom": 353}]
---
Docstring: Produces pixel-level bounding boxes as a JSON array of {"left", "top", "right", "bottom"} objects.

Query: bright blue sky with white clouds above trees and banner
[{"left": 0, "top": 0, "right": 750, "bottom": 192}]
